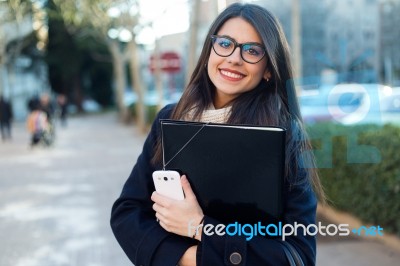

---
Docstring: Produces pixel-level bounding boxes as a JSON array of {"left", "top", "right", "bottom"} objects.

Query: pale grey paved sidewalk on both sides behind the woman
[{"left": 0, "top": 114, "right": 400, "bottom": 266}]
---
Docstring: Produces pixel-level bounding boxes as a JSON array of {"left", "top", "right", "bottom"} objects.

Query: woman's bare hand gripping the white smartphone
[{"left": 151, "top": 175, "right": 204, "bottom": 240}]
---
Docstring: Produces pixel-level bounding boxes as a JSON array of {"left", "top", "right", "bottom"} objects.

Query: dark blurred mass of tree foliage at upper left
[{"left": 45, "top": 0, "right": 113, "bottom": 111}]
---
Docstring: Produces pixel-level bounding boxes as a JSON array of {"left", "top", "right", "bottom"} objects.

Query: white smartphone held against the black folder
[{"left": 153, "top": 170, "right": 185, "bottom": 200}]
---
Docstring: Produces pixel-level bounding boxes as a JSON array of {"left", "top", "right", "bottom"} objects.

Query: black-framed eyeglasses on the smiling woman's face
[{"left": 210, "top": 35, "right": 266, "bottom": 64}]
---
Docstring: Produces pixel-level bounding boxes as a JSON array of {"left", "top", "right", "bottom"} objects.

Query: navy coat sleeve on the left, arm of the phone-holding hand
[{"left": 111, "top": 106, "right": 196, "bottom": 266}]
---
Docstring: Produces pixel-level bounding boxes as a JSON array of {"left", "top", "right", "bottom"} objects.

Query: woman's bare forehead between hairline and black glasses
[{"left": 217, "top": 17, "right": 262, "bottom": 43}]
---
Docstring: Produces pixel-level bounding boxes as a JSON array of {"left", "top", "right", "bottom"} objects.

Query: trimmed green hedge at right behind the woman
[{"left": 308, "top": 123, "right": 400, "bottom": 236}]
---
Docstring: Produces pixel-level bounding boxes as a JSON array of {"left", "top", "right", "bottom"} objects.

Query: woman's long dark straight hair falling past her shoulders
[{"left": 155, "top": 3, "right": 324, "bottom": 201}]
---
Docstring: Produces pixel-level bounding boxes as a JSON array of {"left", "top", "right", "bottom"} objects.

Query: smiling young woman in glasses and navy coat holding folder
[{"left": 111, "top": 4, "right": 323, "bottom": 266}]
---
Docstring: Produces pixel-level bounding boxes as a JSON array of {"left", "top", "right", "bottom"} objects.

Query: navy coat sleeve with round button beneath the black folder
[{"left": 196, "top": 172, "right": 317, "bottom": 266}]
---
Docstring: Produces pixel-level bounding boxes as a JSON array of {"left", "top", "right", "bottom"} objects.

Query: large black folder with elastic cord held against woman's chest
[{"left": 160, "top": 119, "right": 286, "bottom": 224}]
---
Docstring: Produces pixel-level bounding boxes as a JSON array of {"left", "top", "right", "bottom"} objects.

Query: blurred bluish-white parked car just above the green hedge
[{"left": 299, "top": 83, "right": 400, "bottom": 124}]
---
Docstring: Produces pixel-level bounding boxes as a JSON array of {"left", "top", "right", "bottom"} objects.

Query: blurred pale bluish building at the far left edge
[{"left": 0, "top": 5, "right": 49, "bottom": 121}]
